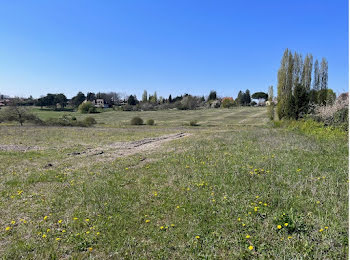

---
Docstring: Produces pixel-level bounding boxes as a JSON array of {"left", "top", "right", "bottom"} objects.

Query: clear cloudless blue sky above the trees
[{"left": 0, "top": 0, "right": 348, "bottom": 98}]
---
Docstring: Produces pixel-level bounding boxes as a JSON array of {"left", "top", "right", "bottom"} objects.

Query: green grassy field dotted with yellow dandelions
[{"left": 0, "top": 108, "right": 349, "bottom": 259}]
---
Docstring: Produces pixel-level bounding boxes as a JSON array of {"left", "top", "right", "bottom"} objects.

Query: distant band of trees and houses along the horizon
[{"left": 0, "top": 90, "right": 277, "bottom": 111}]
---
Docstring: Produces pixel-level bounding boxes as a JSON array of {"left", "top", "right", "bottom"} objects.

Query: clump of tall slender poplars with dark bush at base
[{"left": 277, "top": 49, "right": 336, "bottom": 119}]
